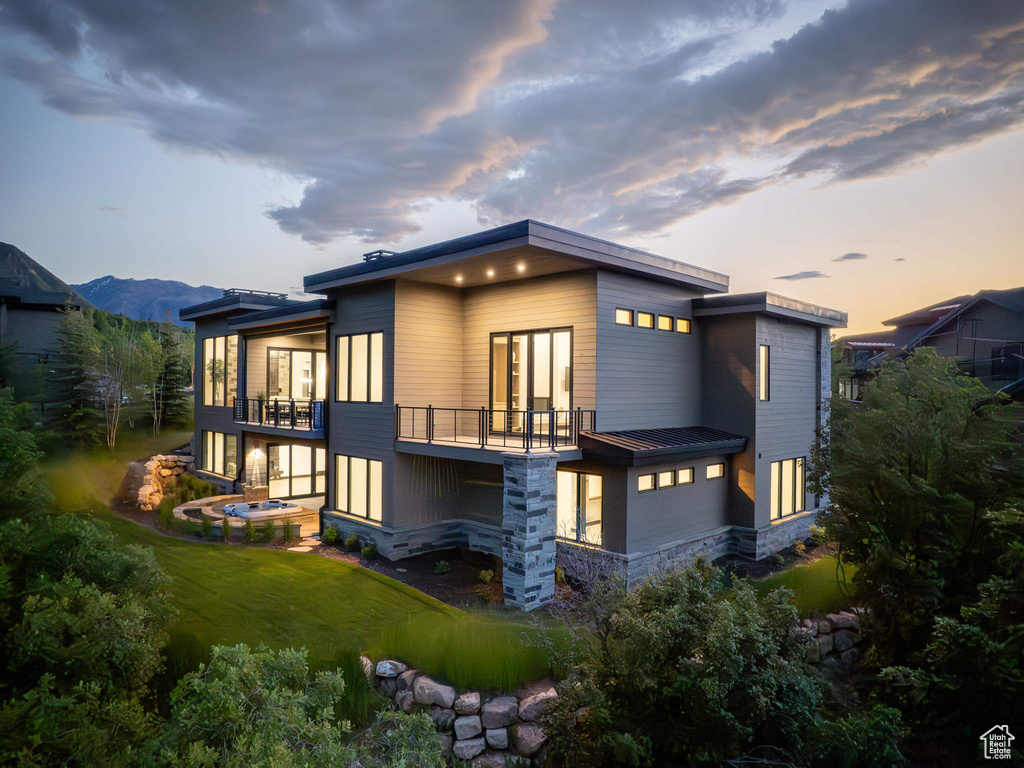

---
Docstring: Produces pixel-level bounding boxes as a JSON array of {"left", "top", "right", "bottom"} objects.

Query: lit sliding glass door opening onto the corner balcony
[{"left": 490, "top": 329, "right": 572, "bottom": 432}]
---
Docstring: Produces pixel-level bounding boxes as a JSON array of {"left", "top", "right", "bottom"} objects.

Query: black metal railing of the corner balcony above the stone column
[{"left": 394, "top": 406, "right": 597, "bottom": 450}]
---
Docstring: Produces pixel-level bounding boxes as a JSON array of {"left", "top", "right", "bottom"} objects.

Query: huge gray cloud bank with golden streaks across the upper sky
[{"left": 0, "top": 0, "right": 1024, "bottom": 244}]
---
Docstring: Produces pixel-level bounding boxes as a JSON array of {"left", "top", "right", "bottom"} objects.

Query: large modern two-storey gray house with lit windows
[{"left": 180, "top": 220, "right": 847, "bottom": 608}]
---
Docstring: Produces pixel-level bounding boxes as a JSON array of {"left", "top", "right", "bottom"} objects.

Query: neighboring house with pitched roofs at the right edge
[{"left": 839, "top": 287, "right": 1024, "bottom": 399}]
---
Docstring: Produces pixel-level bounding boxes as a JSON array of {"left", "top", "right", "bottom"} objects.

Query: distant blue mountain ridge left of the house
[{"left": 72, "top": 274, "right": 224, "bottom": 325}]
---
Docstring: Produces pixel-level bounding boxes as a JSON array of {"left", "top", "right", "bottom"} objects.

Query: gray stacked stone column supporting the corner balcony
[{"left": 502, "top": 453, "right": 557, "bottom": 610}]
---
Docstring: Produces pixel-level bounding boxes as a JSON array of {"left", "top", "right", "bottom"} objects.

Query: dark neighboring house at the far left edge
[{"left": 0, "top": 280, "right": 81, "bottom": 418}]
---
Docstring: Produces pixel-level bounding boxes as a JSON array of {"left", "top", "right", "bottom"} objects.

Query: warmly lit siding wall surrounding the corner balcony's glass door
[{"left": 460, "top": 269, "right": 597, "bottom": 409}]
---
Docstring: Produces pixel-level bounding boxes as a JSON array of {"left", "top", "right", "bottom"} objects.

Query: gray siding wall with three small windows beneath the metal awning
[{"left": 626, "top": 456, "right": 730, "bottom": 553}]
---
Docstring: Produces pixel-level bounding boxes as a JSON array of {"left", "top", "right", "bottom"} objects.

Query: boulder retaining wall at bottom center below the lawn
[{"left": 360, "top": 656, "right": 558, "bottom": 768}]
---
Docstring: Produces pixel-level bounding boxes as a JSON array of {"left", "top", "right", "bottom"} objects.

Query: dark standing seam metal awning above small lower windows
[{"left": 578, "top": 427, "right": 746, "bottom": 467}]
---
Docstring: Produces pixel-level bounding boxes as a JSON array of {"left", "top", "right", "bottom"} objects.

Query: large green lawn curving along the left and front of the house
[{"left": 41, "top": 433, "right": 547, "bottom": 689}]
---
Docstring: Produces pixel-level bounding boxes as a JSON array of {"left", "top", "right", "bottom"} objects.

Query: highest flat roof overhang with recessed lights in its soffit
[{"left": 303, "top": 219, "right": 729, "bottom": 293}]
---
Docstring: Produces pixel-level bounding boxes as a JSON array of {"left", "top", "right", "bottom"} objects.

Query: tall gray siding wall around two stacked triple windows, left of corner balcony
[{"left": 327, "top": 281, "right": 401, "bottom": 526}]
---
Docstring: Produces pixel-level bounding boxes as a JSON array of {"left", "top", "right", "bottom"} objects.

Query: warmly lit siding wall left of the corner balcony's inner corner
[{"left": 394, "top": 281, "right": 463, "bottom": 408}]
